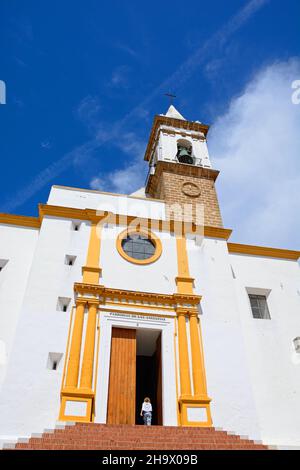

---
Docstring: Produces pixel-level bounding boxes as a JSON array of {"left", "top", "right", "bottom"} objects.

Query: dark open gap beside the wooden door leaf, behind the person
[{"left": 135, "top": 329, "right": 163, "bottom": 425}]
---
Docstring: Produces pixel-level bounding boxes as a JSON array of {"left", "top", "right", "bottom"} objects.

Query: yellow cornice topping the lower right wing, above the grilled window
[{"left": 227, "top": 243, "right": 300, "bottom": 261}]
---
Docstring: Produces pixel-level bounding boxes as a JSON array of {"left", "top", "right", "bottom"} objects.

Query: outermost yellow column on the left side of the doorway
[{"left": 66, "top": 300, "right": 86, "bottom": 387}]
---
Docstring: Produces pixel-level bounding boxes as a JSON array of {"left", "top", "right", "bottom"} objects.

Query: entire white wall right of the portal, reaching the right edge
[{"left": 188, "top": 235, "right": 300, "bottom": 446}]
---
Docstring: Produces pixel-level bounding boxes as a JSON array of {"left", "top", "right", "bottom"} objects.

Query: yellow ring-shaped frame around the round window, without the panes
[{"left": 116, "top": 228, "right": 162, "bottom": 266}]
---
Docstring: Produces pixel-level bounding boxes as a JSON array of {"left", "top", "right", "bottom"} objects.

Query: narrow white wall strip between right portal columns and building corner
[{"left": 188, "top": 238, "right": 260, "bottom": 439}]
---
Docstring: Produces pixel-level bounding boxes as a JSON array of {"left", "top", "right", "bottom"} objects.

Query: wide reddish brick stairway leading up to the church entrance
[{"left": 6, "top": 423, "right": 268, "bottom": 450}]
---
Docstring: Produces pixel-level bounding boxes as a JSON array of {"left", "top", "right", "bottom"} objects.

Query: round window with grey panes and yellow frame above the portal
[{"left": 117, "top": 230, "right": 161, "bottom": 264}]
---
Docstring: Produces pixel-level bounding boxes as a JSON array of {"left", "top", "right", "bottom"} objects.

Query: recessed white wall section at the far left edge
[{"left": 0, "top": 224, "right": 39, "bottom": 390}]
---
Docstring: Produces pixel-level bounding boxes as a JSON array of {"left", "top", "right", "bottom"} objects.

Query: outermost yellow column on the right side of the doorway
[{"left": 190, "top": 312, "right": 207, "bottom": 397}]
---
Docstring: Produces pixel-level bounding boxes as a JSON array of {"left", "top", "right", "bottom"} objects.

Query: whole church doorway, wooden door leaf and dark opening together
[{"left": 107, "top": 327, "right": 163, "bottom": 425}]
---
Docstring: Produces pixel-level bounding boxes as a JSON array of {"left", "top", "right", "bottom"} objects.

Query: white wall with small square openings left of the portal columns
[{"left": 0, "top": 217, "right": 90, "bottom": 437}]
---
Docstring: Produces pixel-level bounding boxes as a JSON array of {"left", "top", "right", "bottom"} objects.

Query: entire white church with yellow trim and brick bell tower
[{"left": 0, "top": 106, "right": 300, "bottom": 446}]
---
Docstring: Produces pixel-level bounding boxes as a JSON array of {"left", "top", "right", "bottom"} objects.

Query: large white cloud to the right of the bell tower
[{"left": 209, "top": 58, "right": 300, "bottom": 249}]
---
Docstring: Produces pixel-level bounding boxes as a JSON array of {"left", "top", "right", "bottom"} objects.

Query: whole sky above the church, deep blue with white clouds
[{"left": 0, "top": 0, "right": 300, "bottom": 248}]
